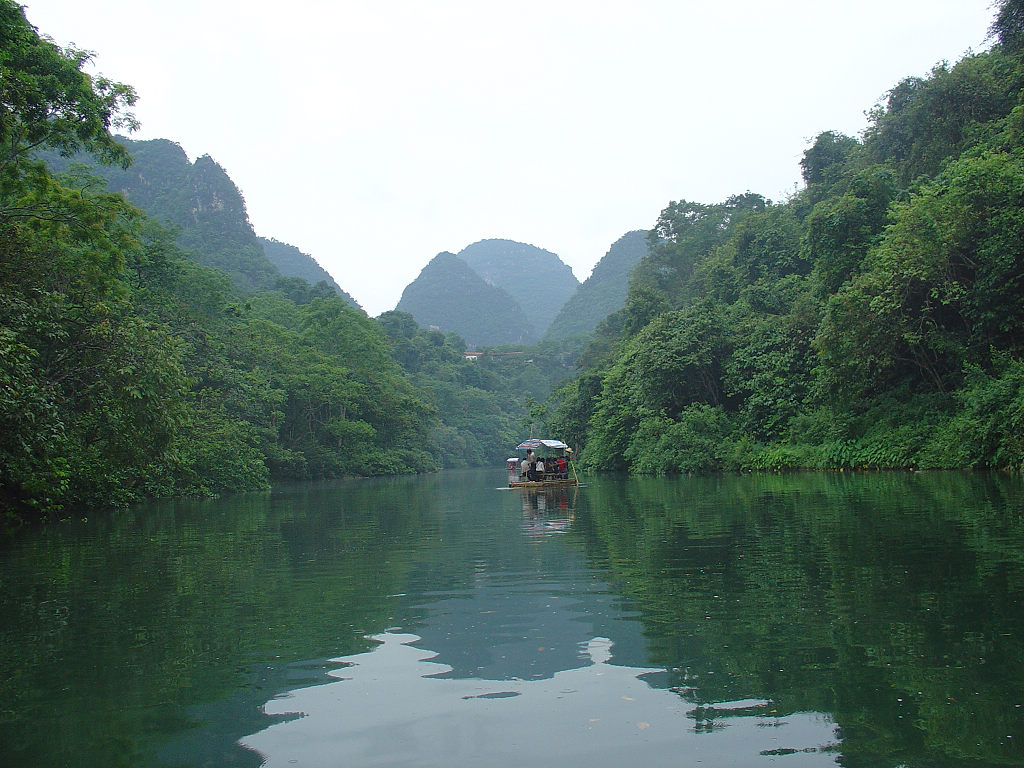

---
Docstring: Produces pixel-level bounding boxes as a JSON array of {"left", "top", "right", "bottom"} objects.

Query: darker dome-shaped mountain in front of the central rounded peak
[{"left": 395, "top": 251, "right": 537, "bottom": 346}]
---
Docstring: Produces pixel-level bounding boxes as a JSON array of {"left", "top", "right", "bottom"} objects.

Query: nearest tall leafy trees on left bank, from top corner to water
[{"left": 0, "top": 6, "right": 196, "bottom": 515}]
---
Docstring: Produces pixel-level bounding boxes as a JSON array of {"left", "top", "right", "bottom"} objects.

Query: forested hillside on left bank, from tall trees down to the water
[{"left": 0, "top": 0, "right": 437, "bottom": 521}]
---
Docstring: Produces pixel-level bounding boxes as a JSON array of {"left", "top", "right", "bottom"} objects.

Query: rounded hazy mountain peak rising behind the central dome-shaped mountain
[{"left": 458, "top": 240, "right": 580, "bottom": 341}]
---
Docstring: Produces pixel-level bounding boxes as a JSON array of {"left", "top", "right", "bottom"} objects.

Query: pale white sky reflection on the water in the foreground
[{"left": 242, "top": 633, "right": 835, "bottom": 768}]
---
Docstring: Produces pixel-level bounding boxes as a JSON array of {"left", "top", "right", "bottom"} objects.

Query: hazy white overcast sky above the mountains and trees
[{"left": 22, "top": 0, "right": 994, "bottom": 315}]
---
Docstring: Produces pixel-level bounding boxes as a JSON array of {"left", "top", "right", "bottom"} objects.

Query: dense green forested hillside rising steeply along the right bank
[{"left": 549, "top": 1, "right": 1024, "bottom": 473}]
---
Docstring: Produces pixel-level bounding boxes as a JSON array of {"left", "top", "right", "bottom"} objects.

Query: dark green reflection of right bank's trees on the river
[{"left": 575, "top": 474, "right": 1024, "bottom": 766}]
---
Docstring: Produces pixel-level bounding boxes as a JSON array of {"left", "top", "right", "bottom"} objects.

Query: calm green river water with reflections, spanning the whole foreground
[{"left": 0, "top": 470, "right": 1024, "bottom": 768}]
